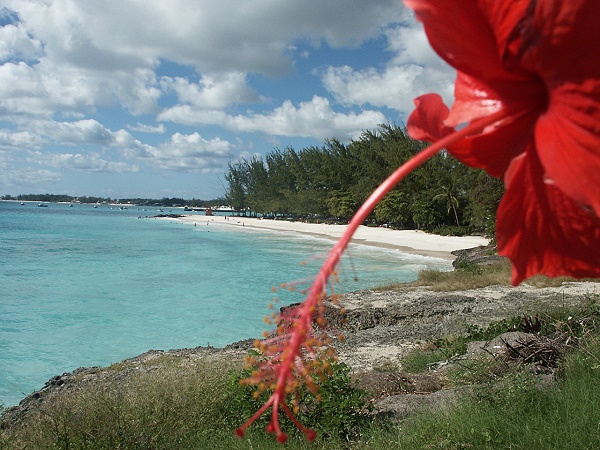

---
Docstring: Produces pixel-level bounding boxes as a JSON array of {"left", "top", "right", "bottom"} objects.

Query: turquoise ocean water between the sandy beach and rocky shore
[{"left": 0, "top": 202, "right": 450, "bottom": 407}]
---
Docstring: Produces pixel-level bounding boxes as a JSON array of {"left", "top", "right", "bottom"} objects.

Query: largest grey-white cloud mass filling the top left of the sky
[{"left": 0, "top": 0, "right": 402, "bottom": 121}]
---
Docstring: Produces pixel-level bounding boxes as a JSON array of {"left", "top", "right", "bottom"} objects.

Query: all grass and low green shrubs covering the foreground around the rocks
[{"left": 0, "top": 263, "right": 600, "bottom": 450}]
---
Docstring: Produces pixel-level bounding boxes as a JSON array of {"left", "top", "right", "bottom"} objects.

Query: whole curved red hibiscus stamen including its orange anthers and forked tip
[{"left": 236, "top": 110, "right": 509, "bottom": 443}]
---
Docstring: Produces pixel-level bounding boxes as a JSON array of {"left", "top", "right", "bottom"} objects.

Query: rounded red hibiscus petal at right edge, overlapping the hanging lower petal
[{"left": 535, "top": 79, "right": 600, "bottom": 219}]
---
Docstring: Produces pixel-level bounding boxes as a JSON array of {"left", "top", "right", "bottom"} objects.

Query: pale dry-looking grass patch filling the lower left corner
[{"left": 5, "top": 359, "right": 246, "bottom": 450}]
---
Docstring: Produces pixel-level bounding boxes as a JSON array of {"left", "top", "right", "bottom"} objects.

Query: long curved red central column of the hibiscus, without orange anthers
[{"left": 237, "top": 110, "right": 508, "bottom": 442}]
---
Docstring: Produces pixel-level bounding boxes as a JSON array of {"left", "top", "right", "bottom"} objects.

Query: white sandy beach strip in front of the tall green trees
[{"left": 180, "top": 215, "right": 488, "bottom": 260}]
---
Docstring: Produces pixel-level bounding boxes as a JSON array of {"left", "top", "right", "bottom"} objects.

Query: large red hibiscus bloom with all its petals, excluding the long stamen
[{"left": 404, "top": 0, "right": 600, "bottom": 284}]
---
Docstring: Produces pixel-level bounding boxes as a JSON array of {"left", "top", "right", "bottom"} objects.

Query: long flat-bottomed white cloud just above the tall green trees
[{"left": 159, "top": 96, "right": 385, "bottom": 140}]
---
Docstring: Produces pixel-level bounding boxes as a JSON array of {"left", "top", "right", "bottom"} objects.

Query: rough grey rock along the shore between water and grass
[{"left": 5, "top": 282, "right": 600, "bottom": 426}]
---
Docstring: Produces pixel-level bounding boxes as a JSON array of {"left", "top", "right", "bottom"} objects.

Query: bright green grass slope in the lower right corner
[{"left": 370, "top": 341, "right": 600, "bottom": 450}]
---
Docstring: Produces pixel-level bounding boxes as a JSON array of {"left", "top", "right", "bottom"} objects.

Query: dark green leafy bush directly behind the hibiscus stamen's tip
[{"left": 228, "top": 363, "right": 372, "bottom": 440}]
